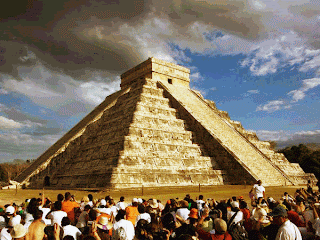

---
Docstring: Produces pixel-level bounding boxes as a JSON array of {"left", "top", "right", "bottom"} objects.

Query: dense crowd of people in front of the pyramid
[{"left": 0, "top": 180, "right": 320, "bottom": 240}]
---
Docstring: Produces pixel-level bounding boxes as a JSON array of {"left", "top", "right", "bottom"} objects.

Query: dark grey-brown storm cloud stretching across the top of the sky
[{"left": 0, "top": 0, "right": 320, "bottom": 80}]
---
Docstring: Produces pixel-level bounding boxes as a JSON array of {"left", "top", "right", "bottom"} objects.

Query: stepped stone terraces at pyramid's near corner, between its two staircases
[{"left": 25, "top": 78, "right": 228, "bottom": 188}]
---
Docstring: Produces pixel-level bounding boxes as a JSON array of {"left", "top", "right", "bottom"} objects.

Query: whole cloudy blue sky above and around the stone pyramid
[{"left": 0, "top": 0, "right": 320, "bottom": 162}]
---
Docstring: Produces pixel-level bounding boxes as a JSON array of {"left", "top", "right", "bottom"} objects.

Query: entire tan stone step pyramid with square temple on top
[{"left": 15, "top": 58, "right": 316, "bottom": 189}]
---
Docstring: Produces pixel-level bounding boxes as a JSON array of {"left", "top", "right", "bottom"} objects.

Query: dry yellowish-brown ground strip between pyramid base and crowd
[{"left": 0, "top": 185, "right": 310, "bottom": 206}]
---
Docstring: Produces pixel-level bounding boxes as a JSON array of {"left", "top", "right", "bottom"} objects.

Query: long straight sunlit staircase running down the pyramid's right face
[{"left": 159, "top": 81, "right": 293, "bottom": 185}]
